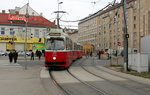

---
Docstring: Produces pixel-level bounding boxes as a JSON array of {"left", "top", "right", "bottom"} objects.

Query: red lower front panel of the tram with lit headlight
[{"left": 45, "top": 51, "right": 72, "bottom": 67}]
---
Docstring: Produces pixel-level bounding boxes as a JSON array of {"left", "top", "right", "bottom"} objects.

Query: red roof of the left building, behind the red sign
[{"left": 0, "top": 13, "right": 56, "bottom": 27}]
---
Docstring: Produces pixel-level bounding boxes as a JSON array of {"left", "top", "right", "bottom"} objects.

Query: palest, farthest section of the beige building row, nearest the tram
[{"left": 78, "top": 12, "right": 99, "bottom": 47}]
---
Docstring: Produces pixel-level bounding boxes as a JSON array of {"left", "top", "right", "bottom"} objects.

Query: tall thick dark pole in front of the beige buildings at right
[{"left": 122, "top": 0, "right": 129, "bottom": 71}]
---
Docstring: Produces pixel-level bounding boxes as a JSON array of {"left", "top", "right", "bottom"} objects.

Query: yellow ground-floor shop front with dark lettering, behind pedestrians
[{"left": 0, "top": 36, "right": 44, "bottom": 51}]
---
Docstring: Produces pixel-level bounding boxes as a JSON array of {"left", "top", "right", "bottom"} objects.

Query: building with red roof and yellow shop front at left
[{"left": 0, "top": 5, "right": 56, "bottom": 51}]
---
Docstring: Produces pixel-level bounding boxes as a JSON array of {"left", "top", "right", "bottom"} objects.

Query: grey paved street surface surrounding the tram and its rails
[{"left": 0, "top": 56, "right": 150, "bottom": 95}]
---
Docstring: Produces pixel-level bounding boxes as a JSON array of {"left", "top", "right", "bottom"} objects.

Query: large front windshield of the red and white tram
[{"left": 46, "top": 37, "right": 65, "bottom": 50}]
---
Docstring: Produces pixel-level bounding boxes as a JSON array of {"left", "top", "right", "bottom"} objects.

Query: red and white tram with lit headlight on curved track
[{"left": 45, "top": 31, "right": 82, "bottom": 68}]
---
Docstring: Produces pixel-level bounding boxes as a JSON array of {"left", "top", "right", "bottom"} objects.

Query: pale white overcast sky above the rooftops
[{"left": 0, "top": 0, "right": 121, "bottom": 28}]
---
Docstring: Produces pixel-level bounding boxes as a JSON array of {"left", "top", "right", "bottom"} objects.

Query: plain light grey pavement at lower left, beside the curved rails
[{"left": 0, "top": 58, "right": 62, "bottom": 95}]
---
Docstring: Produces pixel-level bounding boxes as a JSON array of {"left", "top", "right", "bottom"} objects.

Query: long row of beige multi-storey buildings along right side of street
[{"left": 78, "top": 0, "right": 150, "bottom": 52}]
